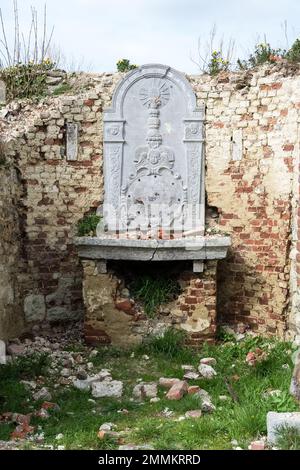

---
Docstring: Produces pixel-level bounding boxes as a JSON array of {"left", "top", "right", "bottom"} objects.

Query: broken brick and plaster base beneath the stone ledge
[{"left": 83, "top": 260, "right": 217, "bottom": 347}]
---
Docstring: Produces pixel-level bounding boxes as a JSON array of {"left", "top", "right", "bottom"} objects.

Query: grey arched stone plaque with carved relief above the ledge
[{"left": 104, "top": 64, "right": 205, "bottom": 235}]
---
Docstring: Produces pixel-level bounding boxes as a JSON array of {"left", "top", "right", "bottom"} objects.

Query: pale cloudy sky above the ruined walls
[{"left": 0, "top": 0, "right": 300, "bottom": 73}]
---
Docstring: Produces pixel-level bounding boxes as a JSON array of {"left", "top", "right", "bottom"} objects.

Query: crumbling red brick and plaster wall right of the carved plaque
[{"left": 190, "top": 67, "right": 300, "bottom": 336}]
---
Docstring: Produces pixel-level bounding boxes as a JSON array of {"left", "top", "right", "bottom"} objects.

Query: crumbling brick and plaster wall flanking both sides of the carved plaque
[{"left": 1, "top": 65, "right": 300, "bottom": 336}]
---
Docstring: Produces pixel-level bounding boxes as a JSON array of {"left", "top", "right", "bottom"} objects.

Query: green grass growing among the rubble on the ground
[{"left": 0, "top": 336, "right": 299, "bottom": 450}]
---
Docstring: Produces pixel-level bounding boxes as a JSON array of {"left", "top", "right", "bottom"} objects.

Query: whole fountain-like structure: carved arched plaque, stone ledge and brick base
[{"left": 76, "top": 64, "right": 230, "bottom": 344}]
